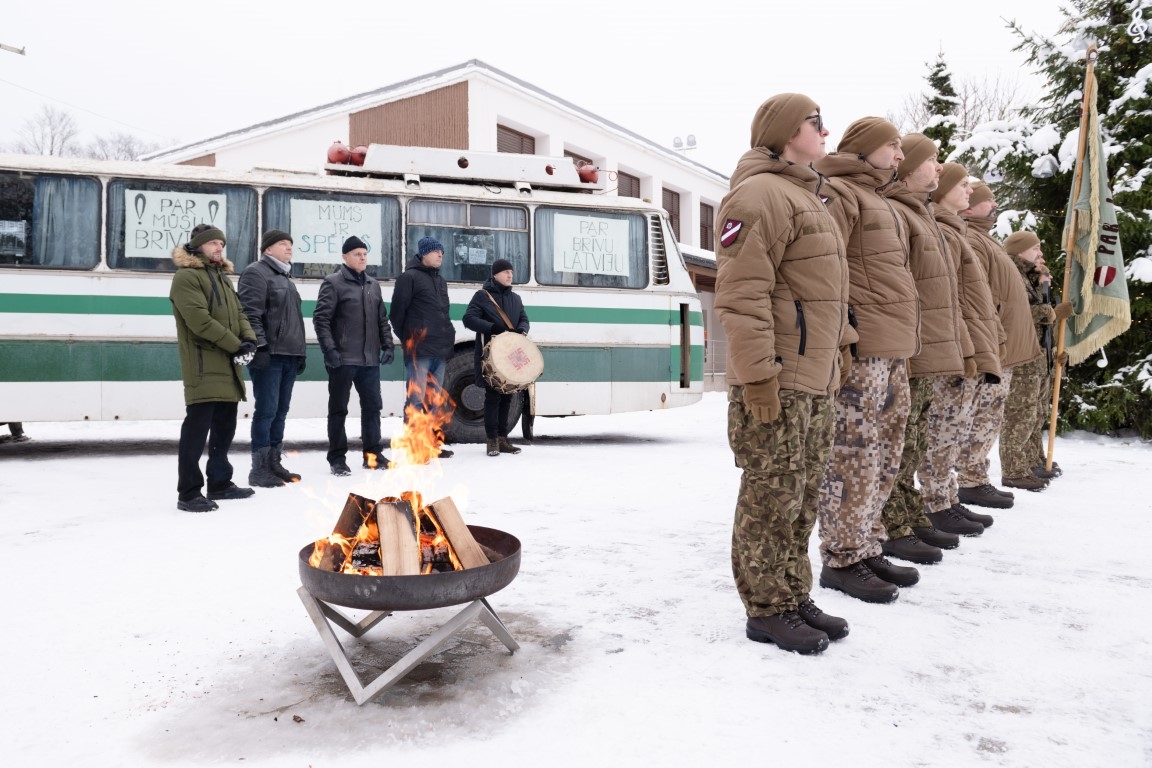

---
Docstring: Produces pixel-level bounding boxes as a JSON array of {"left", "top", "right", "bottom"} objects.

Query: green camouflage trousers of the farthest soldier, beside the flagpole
[{"left": 1000, "top": 357, "right": 1049, "bottom": 478}]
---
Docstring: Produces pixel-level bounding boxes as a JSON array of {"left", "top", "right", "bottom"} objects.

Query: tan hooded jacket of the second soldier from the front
[{"left": 814, "top": 152, "right": 920, "bottom": 359}]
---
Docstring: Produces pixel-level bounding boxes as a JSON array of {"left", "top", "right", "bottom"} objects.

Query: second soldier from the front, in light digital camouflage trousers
[{"left": 814, "top": 117, "right": 920, "bottom": 602}]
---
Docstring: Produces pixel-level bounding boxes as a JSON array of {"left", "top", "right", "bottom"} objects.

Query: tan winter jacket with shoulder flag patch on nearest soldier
[{"left": 715, "top": 147, "right": 857, "bottom": 395}]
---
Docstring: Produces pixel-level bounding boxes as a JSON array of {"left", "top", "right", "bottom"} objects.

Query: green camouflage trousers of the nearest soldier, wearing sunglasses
[{"left": 728, "top": 387, "right": 833, "bottom": 617}]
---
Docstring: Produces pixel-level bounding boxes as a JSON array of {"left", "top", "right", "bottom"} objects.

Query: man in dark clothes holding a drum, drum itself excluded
[{"left": 464, "top": 259, "right": 529, "bottom": 456}]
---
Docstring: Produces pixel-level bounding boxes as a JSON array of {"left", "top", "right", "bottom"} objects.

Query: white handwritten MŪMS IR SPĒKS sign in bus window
[{"left": 289, "top": 199, "right": 382, "bottom": 266}]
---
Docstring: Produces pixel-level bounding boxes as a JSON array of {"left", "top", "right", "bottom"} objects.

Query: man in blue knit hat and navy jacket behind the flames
[{"left": 389, "top": 237, "right": 456, "bottom": 458}]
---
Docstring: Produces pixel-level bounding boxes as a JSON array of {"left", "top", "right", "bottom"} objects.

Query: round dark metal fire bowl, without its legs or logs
[{"left": 300, "top": 525, "right": 520, "bottom": 611}]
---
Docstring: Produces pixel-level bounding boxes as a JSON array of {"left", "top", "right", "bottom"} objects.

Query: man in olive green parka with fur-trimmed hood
[{"left": 168, "top": 225, "right": 256, "bottom": 512}]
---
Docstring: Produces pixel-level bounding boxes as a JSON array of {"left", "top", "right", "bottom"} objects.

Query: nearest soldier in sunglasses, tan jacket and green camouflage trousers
[{"left": 715, "top": 93, "right": 856, "bottom": 653}]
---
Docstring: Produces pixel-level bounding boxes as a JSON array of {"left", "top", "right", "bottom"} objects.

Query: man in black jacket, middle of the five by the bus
[{"left": 312, "top": 236, "right": 395, "bottom": 477}]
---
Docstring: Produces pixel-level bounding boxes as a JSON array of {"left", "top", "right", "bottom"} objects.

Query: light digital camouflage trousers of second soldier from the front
[{"left": 820, "top": 357, "right": 910, "bottom": 568}]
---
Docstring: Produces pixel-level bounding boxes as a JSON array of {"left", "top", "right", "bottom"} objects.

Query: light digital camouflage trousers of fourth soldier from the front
[{"left": 916, "top": 377, "right": 976, "bottom": 512}]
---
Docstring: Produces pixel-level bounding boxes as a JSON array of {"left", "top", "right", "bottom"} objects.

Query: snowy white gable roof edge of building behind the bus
[{"left": 142, "top": 59, "right": 728, "bottom": 181}]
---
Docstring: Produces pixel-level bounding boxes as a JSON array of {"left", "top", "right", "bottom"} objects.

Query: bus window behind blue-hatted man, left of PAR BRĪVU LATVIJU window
[{"left": 407, "top": 200, "right": 528, "bottom": 283}]
